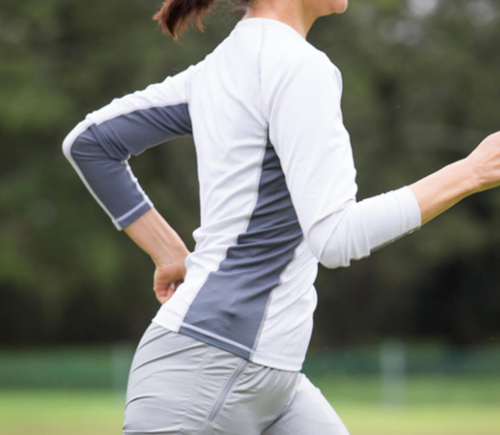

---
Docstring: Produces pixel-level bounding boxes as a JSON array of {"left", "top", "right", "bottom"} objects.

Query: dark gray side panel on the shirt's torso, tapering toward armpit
[{"left": 179, "top": 143, "right": 303, "bottom": 359}]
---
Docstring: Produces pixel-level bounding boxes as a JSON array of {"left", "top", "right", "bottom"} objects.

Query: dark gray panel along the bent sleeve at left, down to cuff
[{"left": 71, "top": 104, "right": 192, "bottom": 228}]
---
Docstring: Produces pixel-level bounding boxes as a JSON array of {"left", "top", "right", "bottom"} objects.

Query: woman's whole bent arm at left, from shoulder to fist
[{"left": 63, "top": 67, "right": 199, "bottom": 303}]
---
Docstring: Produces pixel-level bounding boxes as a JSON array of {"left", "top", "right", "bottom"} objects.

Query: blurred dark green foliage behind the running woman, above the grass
[{"left": 0, "top": 0, "right": 500, "bottom": 346}]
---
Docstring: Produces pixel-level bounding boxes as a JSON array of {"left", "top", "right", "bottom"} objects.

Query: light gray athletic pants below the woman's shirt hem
[{"left": 123, "top": 323, "right": 349, "bottom": 435}]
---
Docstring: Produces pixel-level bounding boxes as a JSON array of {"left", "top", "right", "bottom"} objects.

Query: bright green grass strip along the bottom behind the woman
[{"left": 0, "top": 392, "right": 500, "bottom": 435}]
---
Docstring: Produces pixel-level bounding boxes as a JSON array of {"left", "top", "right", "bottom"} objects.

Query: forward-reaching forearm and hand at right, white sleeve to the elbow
[{"left": 309, "top": 133, "right": 500, "bottom": 267}]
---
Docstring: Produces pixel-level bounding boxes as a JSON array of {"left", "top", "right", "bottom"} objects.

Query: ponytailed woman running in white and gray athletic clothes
[{"left": 64, "top": 0, "right": 500, "bottom": 435}]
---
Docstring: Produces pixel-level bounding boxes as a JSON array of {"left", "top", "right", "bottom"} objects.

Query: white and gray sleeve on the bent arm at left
[{"left": 63, "top": 67, "right": 195, "bottom": 229}]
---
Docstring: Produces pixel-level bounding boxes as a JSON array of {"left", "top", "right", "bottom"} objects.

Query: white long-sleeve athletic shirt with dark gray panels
[{"left": 63, "top": 18, "right": 421, "bottom": 370}]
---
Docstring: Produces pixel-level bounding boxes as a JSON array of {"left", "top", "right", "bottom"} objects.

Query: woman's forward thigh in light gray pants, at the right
[{"left": 262, "top": 374, "right": 349, "bottom": 435}]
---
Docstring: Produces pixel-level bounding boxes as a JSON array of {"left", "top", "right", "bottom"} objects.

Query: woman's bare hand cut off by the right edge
[{"left": 466, "top": 132, "right": 500, "bottom": 192}]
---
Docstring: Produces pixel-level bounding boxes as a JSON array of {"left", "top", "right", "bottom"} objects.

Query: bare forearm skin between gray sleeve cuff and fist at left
[{"left": 124, "top": 208, "right": 189, "bottom": 267}]
